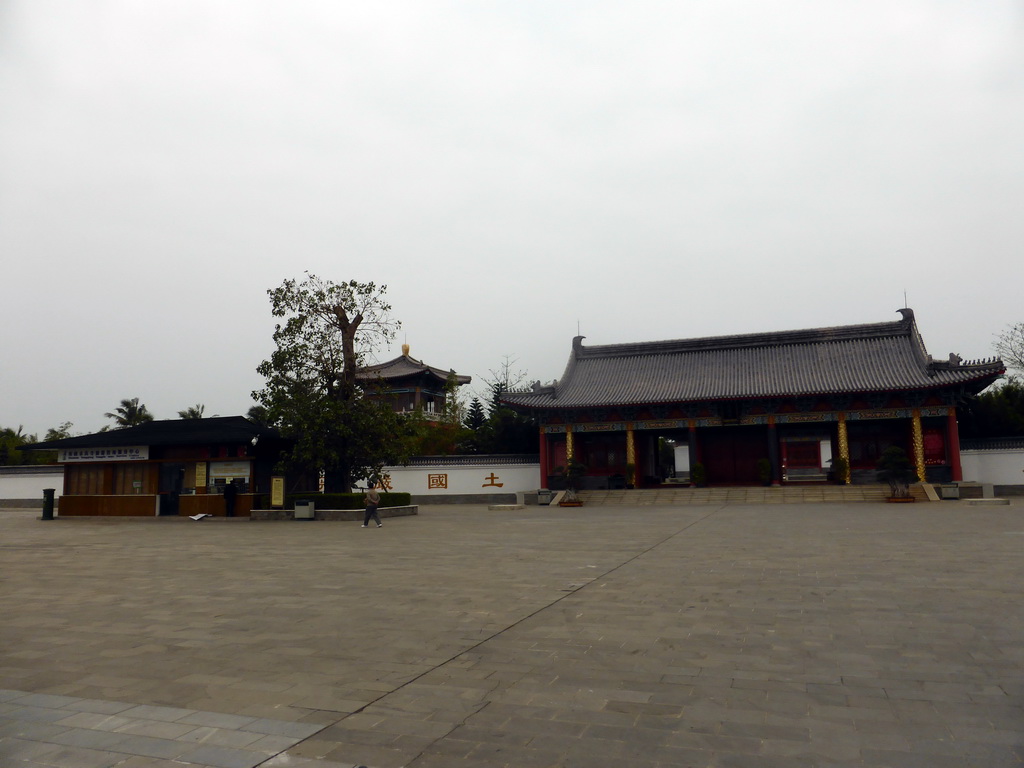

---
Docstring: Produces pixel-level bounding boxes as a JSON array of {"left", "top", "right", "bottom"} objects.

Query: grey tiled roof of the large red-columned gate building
[{"left": 503, "top": 309, "right": 1005, "bottom": 409}]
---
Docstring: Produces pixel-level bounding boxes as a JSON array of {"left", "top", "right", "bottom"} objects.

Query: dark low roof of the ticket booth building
[{"left": 19, "top": 416, "right": 281, "bottom": 451}]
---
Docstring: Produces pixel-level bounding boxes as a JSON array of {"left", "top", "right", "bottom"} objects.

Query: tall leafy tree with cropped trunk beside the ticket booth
[{"left": 252, "top": 272, "right": 408, "bottom": 492}]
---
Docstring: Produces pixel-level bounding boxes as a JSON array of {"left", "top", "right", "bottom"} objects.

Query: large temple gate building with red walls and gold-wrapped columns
[{"left": 503, "top": 309, "right": 1005, "bottom": 488}]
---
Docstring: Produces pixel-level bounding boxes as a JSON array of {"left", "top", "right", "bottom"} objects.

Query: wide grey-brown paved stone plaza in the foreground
[{"left": 0, "top": 500, "right": 1024, "bottom": 768}]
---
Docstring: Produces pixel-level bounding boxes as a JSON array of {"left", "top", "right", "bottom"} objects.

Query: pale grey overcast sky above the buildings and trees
[{"left": 0, "top": 0, "right": 1024, "bottom": 437}]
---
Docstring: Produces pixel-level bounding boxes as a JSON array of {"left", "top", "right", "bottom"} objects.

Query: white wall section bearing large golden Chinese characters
[{"left": 385, "top": 464, "right": 541, "bottom": 496}]
